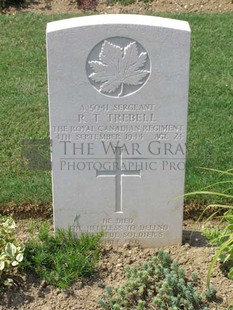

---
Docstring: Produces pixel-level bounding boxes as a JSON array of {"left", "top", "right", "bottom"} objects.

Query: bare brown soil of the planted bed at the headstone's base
[{"left": 0, "top": 218, "right": 233, "bottom": 310}]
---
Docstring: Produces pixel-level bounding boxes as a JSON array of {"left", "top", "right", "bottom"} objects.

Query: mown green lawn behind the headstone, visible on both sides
[{"left": 0, "top": 13, "right": 233, "bottom": 205}]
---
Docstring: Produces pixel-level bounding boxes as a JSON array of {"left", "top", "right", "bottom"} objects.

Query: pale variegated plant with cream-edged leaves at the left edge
[{"left": 0, "top": 216, "right": 24, "bottom": 285}]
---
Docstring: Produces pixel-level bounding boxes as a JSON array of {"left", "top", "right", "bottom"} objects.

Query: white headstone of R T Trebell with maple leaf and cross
[{"left": 47, "top": 15, "right": 190, "bottom": 247}]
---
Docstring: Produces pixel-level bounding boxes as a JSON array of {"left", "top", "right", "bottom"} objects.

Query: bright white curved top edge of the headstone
[{"left": 46, "top": 14, "right": 191, "bottom": 34}]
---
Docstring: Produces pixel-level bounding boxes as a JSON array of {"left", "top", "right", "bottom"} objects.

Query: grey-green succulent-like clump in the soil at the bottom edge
[{"left": 99, "top": 251, "right": 211, "bottom": 310}]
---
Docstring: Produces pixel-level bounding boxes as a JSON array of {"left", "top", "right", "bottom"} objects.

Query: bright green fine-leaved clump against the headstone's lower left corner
[{"left": 22, "top": 222, "right": 102, "bottom": 289}]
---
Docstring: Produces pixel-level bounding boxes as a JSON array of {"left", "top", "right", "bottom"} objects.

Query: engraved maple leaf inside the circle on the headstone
[{"left": 88, "top": 40, "right": 150, "bottom": 97}]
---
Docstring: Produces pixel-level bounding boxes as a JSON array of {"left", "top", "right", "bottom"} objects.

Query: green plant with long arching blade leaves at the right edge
[{"left": 186, "top": 168, "right": 233, "bottom": 286}]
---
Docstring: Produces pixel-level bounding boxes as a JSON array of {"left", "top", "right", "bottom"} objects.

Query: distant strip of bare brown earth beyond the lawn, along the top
[{"left": 4, "top": 0, "right": 233, "bottom": 14}]
